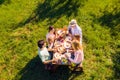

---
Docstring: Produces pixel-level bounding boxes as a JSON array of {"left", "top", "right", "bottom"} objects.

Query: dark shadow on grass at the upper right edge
[{"left": 99, "top": 12, "right": 120, "bottom": 36}]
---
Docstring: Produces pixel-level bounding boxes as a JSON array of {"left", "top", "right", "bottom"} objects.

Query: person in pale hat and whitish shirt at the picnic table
[{"left": 68, "top": 19, "right": 82, "bottom": 44}]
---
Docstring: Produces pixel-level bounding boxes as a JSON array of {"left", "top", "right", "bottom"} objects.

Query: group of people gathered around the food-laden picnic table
[{"left": 38, "top": 19, "right": 84, "bottom": 70}]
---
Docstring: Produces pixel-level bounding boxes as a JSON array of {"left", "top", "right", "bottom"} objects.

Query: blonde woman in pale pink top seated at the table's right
[{"left": 65, "top": 40, "right": 84, "bottom": 71}]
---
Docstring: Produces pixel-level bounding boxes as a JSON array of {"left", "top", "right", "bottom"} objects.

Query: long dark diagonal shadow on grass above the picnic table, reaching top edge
[{"left": 16, "top": 0, "right": 85, "bottom": 28}]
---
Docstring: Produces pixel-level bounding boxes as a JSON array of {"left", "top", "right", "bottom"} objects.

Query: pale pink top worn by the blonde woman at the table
[{"left": 68, "top": 50, "right": 84, "bottom": 64}]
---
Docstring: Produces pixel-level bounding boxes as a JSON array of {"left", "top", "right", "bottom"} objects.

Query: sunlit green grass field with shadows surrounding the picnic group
[{"left": 0, "top": 0, "right": 120, "bottom": 80}]
